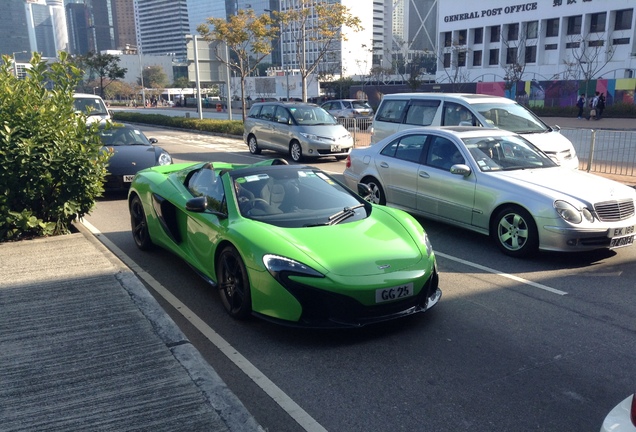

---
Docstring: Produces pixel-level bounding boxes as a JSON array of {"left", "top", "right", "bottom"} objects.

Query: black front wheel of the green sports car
[{"left": 216, "top": 246, "right": 252, "bottom": 319}]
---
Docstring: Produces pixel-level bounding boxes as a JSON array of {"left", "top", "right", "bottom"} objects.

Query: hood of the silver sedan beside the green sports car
[{"left": 496, "top": 167, "right": 636, "bottom": 205}]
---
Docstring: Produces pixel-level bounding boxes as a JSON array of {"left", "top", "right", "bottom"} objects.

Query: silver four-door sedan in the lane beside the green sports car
[{"left": 344, "top": 126, "right": 636, "bottom": 256}]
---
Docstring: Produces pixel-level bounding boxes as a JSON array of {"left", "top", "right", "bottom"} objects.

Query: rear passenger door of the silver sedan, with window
[{"left": 375, "top": 133, "right": 427, "bottom": 210}]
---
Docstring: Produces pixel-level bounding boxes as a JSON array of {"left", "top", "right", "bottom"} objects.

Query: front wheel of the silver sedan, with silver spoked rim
[{"left": 490, "top": 206, "right": 539, "bottom": 258}]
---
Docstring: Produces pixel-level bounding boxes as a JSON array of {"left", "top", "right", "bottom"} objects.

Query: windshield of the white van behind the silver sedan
[{"left": 471, "top": 103, "right": 548, "bottom": 133}]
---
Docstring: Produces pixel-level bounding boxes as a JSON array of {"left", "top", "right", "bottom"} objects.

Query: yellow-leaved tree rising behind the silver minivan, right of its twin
[{"left": 276, "top": 0, "right": 364, "bottom": 102}]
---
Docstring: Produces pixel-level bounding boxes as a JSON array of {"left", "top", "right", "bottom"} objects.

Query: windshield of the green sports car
[{"left": 231, "top": 166, "right": 368, "bottom": 228}]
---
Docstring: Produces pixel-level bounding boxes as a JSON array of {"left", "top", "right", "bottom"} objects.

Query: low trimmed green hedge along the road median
[{"left": 113, "top": 111, "right": 243, "bottom": 136}]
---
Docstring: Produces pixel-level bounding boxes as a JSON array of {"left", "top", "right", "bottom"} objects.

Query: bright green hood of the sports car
[{"left": 264, "top": 208, "right": 423, "bottom": 278}]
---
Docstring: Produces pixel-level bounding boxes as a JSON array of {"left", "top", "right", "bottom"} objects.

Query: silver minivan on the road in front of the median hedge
[{"left": 243, "top": 102, "right": 353, "bottom": 162}]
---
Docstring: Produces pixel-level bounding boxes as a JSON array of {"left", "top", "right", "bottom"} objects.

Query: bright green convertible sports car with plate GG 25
[{"left": 128, "top": 159, "right": 441, "bottom": 328}]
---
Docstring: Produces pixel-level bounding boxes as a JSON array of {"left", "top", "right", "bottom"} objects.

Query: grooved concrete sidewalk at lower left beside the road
[{"left": 0, "top": 224, "right": 263, "bottom": 432}]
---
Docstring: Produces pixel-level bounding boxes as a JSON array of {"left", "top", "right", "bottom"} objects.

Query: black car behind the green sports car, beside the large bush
[{"left": 99, "top": 123, "right": 172, "bottom": 191}]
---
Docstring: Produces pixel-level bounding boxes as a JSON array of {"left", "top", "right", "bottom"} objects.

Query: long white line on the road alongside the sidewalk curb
[{"left": 81, "top": 219, "right": 327, "bottom": 432}]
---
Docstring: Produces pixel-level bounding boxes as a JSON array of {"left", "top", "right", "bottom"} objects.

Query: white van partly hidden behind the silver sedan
[{"left": 371, "top": 93, "right": 579, "bottom": 169}]
